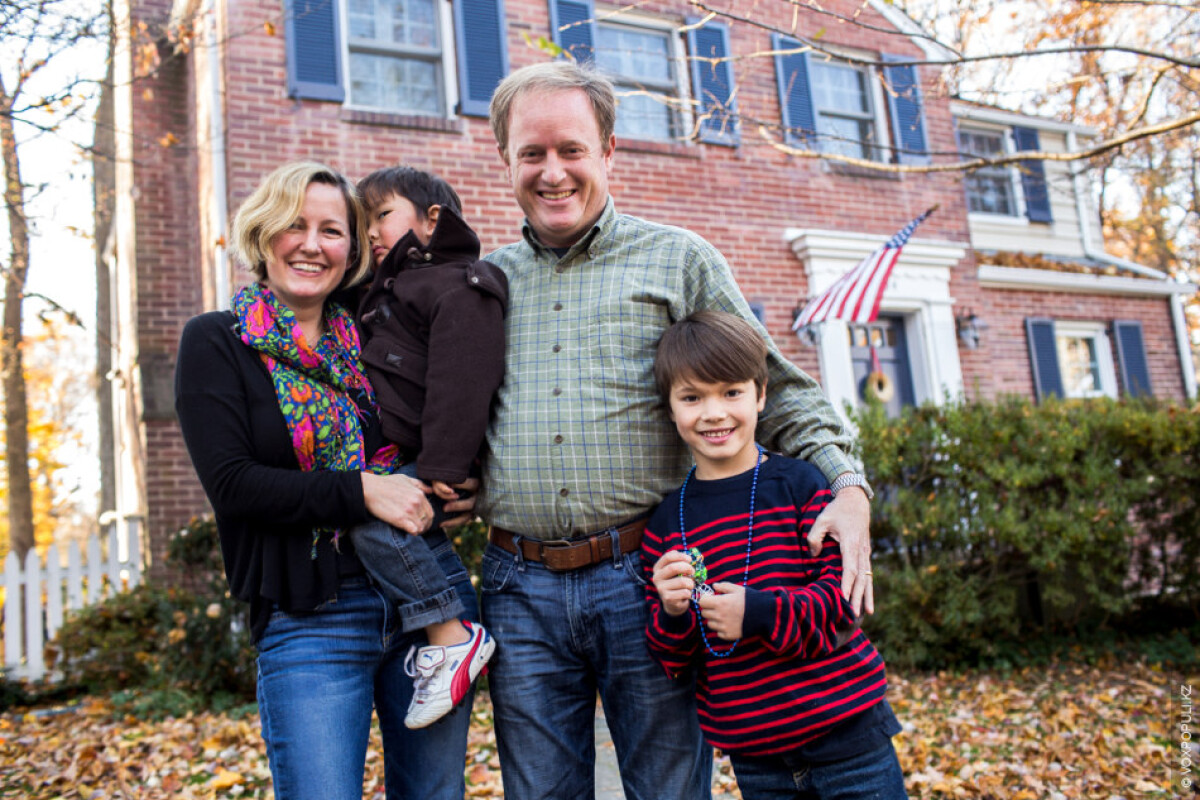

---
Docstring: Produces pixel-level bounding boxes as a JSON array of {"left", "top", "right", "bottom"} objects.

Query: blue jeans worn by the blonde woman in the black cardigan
[{"left": 258, "top": 542, "right": 479, "bottom": 800}]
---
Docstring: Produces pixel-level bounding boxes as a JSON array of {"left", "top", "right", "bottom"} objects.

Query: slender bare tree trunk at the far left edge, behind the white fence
[{"left": 0, "top": 79, "right": 34, "bottom": 559}]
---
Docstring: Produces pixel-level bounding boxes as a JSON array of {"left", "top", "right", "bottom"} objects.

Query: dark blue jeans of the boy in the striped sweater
[{"left": 730, "top": 741, "right": 908, "bottom": 800}]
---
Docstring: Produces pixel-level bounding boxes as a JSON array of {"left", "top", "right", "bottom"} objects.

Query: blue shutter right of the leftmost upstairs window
[{"left": 454, "top": 0, "right": 509, "bottom": 116}]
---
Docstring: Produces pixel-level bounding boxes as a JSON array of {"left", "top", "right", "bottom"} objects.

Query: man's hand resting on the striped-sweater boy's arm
[{"left": 809, "top": 486, "right": 875, "bottom": 616}]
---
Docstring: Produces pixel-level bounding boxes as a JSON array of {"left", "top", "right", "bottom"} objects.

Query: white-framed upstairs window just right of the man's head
[{"left": 595, "top": 13, "right": 689, "bottom": 142}]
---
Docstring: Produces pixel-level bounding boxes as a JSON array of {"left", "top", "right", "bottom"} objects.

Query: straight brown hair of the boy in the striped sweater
[{"left": 654, "top": 311, "right": 767, "bottom": 403}]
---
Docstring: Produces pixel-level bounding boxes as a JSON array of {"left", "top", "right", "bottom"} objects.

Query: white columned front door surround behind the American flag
[{"left": 784, "top": 228, "right": 967, "bottom": 420}]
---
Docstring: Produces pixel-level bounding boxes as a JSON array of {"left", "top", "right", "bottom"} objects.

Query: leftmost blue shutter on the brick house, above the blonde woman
[{"left": 283, "top": 0, "right": 346, "bottom": 103}]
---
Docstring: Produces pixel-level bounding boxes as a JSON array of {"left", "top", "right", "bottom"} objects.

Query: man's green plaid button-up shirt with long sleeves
[{"left": 478, "top": 198, "right": 858, "bottom": 539}]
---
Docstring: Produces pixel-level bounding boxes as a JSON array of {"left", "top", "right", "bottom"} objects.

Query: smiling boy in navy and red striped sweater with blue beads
[{"left": 642, "top": 311, "right": 906, "bottom": 800}]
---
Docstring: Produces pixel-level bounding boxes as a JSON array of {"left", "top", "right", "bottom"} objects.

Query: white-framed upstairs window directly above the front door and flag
[{"left": 810, "top": 59, "right": 878, "bottom": 161}]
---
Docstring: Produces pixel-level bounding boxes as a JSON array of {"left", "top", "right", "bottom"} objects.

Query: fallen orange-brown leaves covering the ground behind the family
[{"left": 0, "top": 664, "right": 1180, "bottom": 800}]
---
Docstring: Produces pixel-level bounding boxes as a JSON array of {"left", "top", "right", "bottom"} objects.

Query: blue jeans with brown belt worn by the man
[{"left": 482, "top": 541, "right": 713, "bottom": 800}]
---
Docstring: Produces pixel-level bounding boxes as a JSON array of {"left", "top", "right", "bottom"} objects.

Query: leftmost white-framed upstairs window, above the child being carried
[{"left": 344, "top": 0, "right": 455, "bottom": 116}]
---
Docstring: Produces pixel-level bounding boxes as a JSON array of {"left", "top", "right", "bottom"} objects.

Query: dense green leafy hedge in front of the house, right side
[{"left": 854, "top": 398, "right": 1200, "bottom": 667}]
